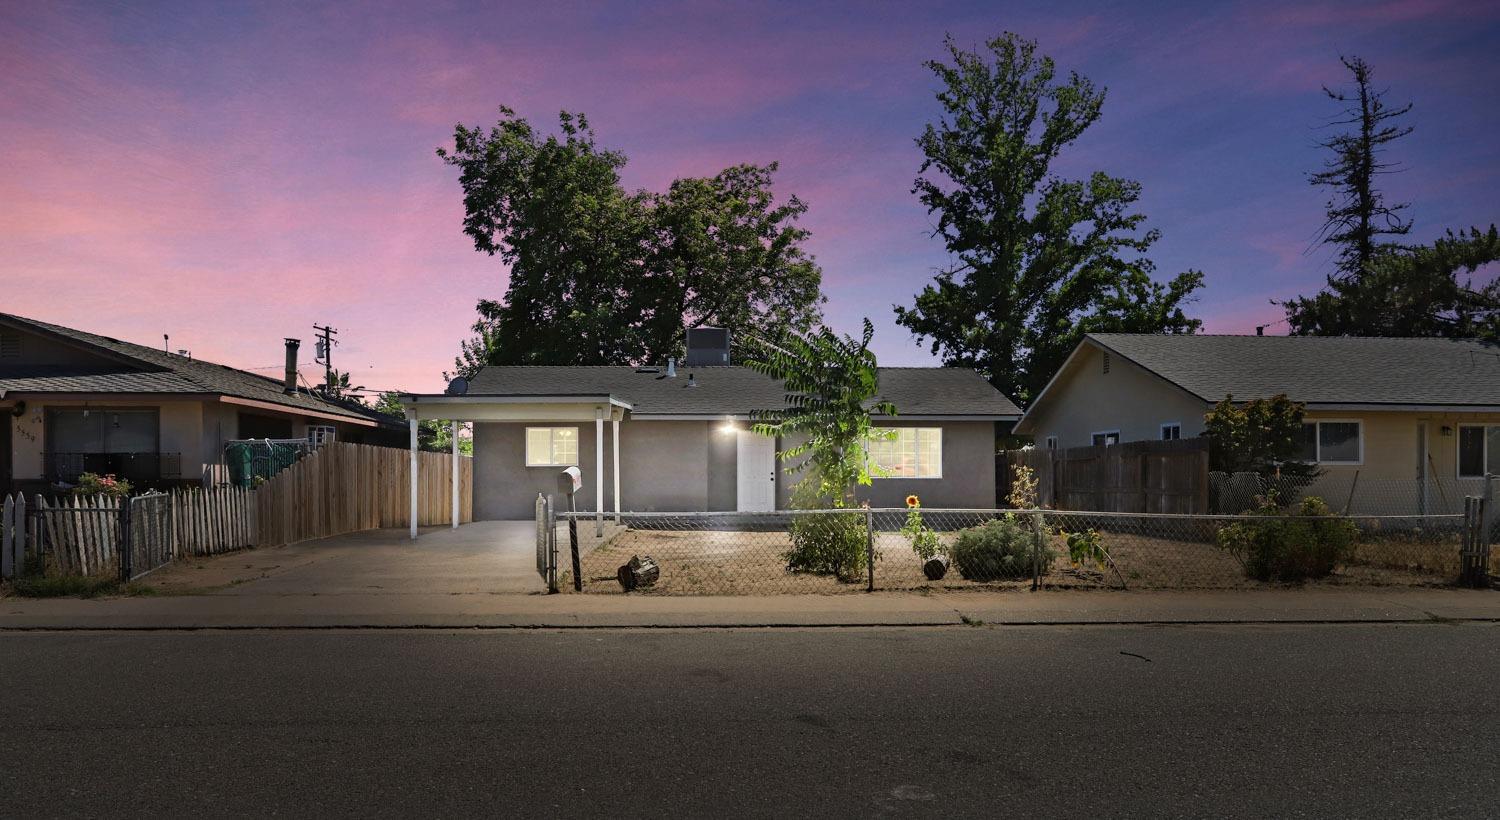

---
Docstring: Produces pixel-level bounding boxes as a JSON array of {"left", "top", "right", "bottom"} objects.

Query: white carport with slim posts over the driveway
[{"left": 401, "top": 392, "right": 632, "bottom": 538}]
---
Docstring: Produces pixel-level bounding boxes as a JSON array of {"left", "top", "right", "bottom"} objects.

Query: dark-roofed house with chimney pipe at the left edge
[{"left": 0, "top": 313, "right": 405, "bottom": 492}]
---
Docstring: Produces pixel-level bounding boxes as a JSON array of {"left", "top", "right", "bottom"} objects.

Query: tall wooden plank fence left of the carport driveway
[{"left": 255, "top": 442, "right": 474, "bottom": 547}]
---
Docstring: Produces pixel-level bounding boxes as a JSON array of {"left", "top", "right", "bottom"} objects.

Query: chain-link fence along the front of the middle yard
[{"left": 558, "top": 510, "right": 1482, "bottom": 595}]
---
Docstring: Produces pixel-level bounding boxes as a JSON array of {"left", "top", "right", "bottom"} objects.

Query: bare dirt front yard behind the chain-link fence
[{"left": 563, "top": 529, "right": 1458, "bottom": 595}]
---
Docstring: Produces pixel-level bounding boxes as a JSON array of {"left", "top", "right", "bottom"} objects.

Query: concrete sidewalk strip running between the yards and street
[{"left": 0, "top": 589, "right": 1500, "bottom": 631}]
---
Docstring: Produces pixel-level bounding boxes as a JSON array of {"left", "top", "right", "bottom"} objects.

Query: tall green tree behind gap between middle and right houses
[{"left": 896, "top": 33, "right": 1203, "bottom": 406}]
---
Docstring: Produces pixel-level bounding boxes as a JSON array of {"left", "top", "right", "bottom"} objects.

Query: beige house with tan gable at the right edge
[{"left": 1016, "top": 333, "right": 1500, "bottom": 513}]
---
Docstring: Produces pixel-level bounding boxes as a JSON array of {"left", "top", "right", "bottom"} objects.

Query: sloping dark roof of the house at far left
[{"left": 0, "top": 313, "right": 402, "bottom": 424}]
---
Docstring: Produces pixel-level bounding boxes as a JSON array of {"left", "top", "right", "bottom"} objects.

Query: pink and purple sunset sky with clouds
[{"left": 0, "top": 0, "right": 1500, "bottom": 390}]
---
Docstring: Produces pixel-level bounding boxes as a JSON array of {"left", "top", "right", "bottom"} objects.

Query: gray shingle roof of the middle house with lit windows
[{"left": 468, "top": 366, "right": 1022, "bottom": 420}]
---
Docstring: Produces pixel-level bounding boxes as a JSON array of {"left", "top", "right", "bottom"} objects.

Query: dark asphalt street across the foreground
[{"left": 0, "top": 624, "right": 1500, "bottom": 817}]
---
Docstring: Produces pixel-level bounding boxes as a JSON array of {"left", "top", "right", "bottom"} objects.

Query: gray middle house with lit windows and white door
[{"left": 404, "top": 331, "right": 1020, "bottom": 519}]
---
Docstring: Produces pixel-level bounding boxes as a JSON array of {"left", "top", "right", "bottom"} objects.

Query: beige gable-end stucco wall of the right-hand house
[{"left": 1020, "top": 345, "right": 1209, "bottom": 447}]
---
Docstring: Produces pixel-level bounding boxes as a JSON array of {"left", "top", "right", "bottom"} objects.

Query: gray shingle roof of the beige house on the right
[{"left": 1088, "top": 333, "right": 1500, "bottom": 406}]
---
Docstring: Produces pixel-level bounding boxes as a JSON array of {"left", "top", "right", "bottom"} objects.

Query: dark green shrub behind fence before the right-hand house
[{"left": 1218, "top": 496, "right": 1359, "bottom": 582}]
